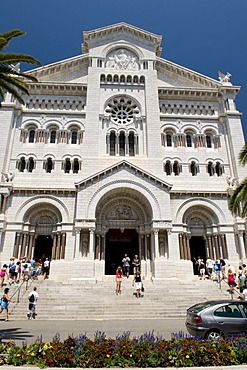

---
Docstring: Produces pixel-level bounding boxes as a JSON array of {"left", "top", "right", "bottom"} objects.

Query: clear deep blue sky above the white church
[{"left": 0, "top": 0, "right": 247, "bottom": 138}]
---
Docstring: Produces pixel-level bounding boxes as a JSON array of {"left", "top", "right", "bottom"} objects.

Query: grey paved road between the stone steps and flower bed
[{"left": 0, "top": 318, "right": 187, "bottom": 344}]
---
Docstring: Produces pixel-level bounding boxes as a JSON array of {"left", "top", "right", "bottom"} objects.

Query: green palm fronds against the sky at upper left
[{"left": 0, "top": 30, "right": 41, "bottom": 105}]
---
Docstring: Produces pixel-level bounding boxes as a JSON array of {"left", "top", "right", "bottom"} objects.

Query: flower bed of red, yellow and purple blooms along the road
[{"left": 0, "top": 332, "right": 247, "bottom": 368}]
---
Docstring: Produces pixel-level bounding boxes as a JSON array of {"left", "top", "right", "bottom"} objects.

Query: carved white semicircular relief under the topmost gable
[{"left": 106, "top": 49, "right": 139, "bottom": 71}]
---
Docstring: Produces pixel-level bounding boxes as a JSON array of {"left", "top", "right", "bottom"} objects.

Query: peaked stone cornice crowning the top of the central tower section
[{"left": 82, "top": 22, "right": 162, "bottom": 56}]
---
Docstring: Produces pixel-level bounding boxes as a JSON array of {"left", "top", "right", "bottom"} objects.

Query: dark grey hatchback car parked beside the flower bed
[{"left": 185, "top": 300, "right": 247, "bottom": 340}]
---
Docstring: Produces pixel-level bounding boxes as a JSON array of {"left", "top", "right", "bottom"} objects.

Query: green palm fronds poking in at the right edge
[{"left": 230, "top": 142, "right": 247, "bottom": 218}]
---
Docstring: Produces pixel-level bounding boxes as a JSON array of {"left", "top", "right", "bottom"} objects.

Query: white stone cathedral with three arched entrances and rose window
[{"left": 0, "top": 23, "right": 247, "bottom": 280}]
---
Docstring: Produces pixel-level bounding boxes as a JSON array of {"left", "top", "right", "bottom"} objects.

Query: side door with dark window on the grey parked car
[{"left": 214, "top": 302, "right": 247, "bottom": 335}]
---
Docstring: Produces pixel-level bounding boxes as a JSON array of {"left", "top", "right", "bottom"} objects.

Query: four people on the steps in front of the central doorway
[{"left": 115, "top": 254, "right": 143, "bottom": 298}]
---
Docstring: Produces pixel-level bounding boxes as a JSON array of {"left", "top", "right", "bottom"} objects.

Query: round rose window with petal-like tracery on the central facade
[{"left": 105, "top": 98, "right": 139, "bottom": 125}]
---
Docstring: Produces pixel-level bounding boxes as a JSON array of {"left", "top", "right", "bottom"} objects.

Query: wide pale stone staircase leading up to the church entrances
[{"left": 5, "top": 276, "right": 237, "bottom": 320}]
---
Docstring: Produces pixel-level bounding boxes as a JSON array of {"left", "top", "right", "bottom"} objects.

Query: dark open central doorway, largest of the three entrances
[{"left": 105, "top": 229, "right": 139, "bottom": 275}]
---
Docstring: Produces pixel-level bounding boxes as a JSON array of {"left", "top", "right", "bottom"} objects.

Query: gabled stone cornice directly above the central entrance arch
[{"left": 75, "top": 160, "right": 172, "bottom": 190}]
